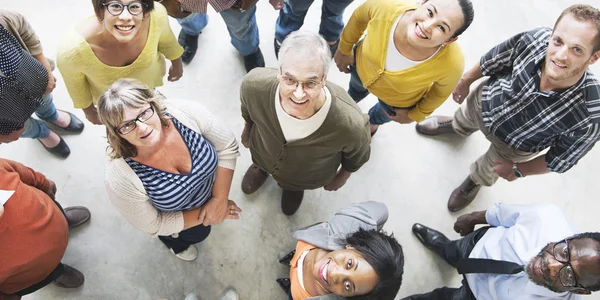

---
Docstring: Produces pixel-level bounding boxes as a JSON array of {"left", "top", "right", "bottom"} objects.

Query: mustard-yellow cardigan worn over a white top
[{"left": 339, "top": 0, "right": 464, "bottom": 122}]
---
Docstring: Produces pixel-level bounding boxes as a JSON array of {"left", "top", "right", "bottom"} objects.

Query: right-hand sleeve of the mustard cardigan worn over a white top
[{"left": 408, "top": 44, "right": 465, "bottom": 122}]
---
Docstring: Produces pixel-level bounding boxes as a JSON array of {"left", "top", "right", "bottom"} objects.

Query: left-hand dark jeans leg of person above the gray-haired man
[{"left": 275, "top": 0, "right": 313, "bottom": 43}]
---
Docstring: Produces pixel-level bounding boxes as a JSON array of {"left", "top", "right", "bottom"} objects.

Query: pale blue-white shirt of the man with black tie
[{"left": 466, "top": 203, "right": 579, "bottom": 300}]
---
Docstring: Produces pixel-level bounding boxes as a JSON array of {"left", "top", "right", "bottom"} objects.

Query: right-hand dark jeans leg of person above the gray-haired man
[{"left": 319, "top": 0, "right": 352, "bottom": 42}]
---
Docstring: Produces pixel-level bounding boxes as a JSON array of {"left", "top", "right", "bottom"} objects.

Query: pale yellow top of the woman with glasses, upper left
[{"left": 57, "top": 2, "right": 183, "bottom": 108}]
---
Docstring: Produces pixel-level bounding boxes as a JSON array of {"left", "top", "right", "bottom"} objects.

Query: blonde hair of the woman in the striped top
[{"left": 98, "top": 78, "right": 169, "bottom": 159}]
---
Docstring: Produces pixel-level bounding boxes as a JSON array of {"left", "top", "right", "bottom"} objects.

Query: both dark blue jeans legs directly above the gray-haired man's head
[{"left": 275, "top": 0, "right": 352, "bottom": 42}]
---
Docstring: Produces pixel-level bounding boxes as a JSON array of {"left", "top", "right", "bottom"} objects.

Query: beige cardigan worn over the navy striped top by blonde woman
[{"left": 104, "top": 100, "right": 239, "bottom": 236}]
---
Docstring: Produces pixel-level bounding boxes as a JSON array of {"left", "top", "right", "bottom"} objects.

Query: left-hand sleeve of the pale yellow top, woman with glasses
[{"left": 56, "top": 29, "right": 93, "bottom": 109}]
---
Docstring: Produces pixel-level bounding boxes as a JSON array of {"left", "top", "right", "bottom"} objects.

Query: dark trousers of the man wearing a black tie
[{"left": 403, "top": 227, "right": 490, "bottom": 300}]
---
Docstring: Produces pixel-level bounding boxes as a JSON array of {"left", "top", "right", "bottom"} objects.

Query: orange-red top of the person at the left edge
[{"left": 0, "top": 159, "right": 69, "bottom": 299}]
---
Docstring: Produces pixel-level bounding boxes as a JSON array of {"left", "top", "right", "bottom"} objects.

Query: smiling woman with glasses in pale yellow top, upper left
[{"left": 57, "top": 0, "right": 183, "bottom": 125}]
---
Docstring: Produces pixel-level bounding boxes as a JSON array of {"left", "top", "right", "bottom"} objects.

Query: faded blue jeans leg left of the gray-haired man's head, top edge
[{"left": 221, "top": 5, "right": 259, "bottom": 56}]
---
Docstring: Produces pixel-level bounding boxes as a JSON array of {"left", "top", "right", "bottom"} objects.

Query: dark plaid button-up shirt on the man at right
[{"left": 480, "top": 28, "right": 600, "bottom": 173}]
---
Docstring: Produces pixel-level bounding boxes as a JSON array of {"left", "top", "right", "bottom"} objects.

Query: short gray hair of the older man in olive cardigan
[{"left": 279, "top": 30, "right": 331, "bottom": 76}]
